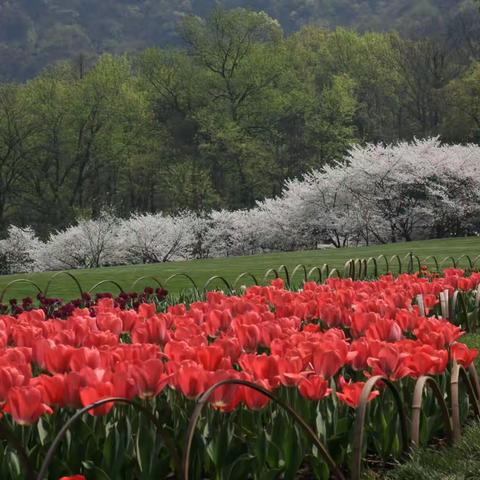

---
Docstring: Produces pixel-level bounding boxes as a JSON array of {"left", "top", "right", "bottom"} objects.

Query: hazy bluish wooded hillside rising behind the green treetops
[{"left": 0, "top": 0, "right": 480, "bottom": 80}]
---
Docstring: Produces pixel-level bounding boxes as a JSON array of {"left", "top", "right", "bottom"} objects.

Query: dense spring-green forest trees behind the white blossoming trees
[{"left": 0, "top": 5, "right": 480, "bottom": 237}]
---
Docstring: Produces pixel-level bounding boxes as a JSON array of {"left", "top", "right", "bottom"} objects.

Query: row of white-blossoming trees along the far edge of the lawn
[{"left": 0, "top": 138, "right": 480, "bottom": 273}]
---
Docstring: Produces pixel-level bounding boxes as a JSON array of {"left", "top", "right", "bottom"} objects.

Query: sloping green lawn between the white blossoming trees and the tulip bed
[{"left": 0, "top": 237, "right": 480, "bottom": 300}]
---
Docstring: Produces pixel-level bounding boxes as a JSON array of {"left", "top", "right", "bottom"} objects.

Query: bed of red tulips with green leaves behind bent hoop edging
[{"left": 0, "top": 269, "right": 480, "bottom": 480}]
